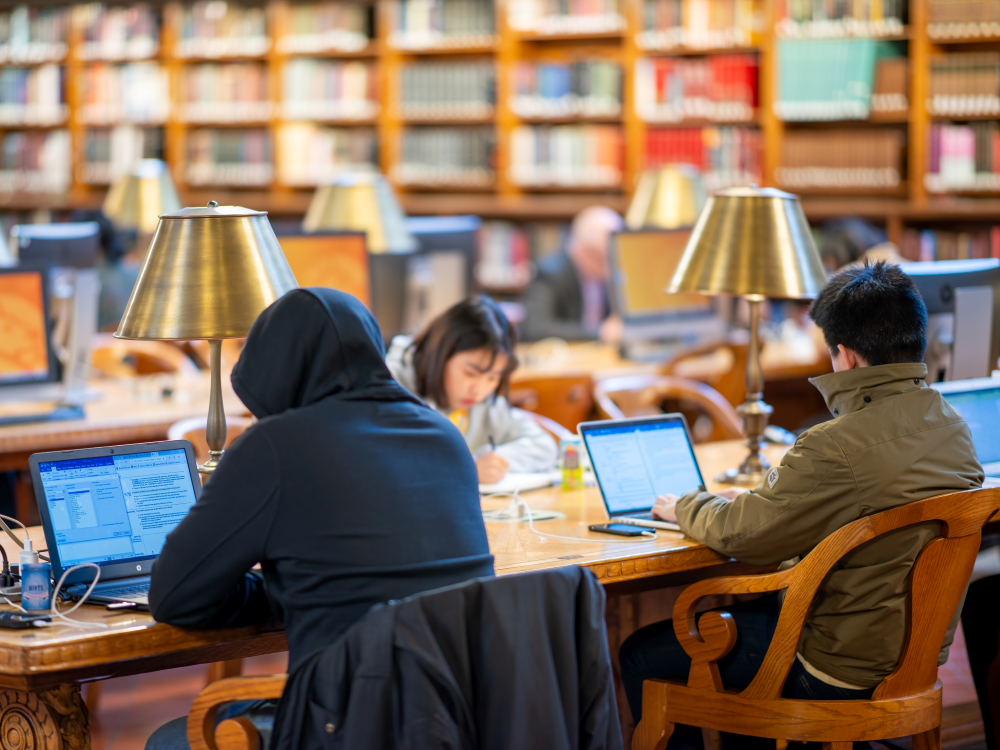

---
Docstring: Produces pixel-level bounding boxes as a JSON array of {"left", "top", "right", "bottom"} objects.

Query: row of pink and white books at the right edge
[{"left": 924, "top": 121, "right": 1000, "bottom": 193}]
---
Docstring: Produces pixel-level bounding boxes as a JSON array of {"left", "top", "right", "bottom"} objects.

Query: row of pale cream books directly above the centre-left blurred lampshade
[{"left": 278, "top": 123, "right": 378, "bottom": 187}]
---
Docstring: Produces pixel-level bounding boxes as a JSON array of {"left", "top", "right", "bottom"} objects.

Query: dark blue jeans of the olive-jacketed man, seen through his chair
[{"left": 619, "top": 594, "right": 872, "bottom": 750}]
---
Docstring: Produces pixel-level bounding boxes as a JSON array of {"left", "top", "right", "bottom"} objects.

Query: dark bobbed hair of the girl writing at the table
[{"left": 412, "top": 296, "right": 517, "bottom": 406}]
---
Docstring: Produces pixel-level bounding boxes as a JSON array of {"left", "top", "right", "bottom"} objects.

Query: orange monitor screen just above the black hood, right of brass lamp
[{"left": 278, "top": 232, "right": 372, "bottom": 309}]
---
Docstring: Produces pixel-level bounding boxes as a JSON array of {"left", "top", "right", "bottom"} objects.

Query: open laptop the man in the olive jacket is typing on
[{"left": 577, "top": 414, "right": 705, "bottom": 531}]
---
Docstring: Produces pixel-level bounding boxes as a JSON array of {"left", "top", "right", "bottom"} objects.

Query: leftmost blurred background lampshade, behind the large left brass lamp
[{"left": 102, "top": 159, "right": 181, "bottom": 234}]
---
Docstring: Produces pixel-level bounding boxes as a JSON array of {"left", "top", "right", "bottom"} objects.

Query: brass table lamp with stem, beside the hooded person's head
[{"left": 115, "top": 201, "right": 298, "bottom": 474}]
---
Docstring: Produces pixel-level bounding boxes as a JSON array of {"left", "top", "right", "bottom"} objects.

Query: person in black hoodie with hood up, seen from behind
[{"left": 147, "top": 288, "right": 493, "bottom": 748}]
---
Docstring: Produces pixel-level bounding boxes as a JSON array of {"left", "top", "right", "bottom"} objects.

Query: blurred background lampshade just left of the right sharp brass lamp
[{"left": 625, "top": 164, "right": 705, "bottom": 229}]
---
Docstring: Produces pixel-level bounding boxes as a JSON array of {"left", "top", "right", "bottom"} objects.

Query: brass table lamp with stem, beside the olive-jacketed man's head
[{"left": 666, "top": 186, "right": 827, "bottom": 486}]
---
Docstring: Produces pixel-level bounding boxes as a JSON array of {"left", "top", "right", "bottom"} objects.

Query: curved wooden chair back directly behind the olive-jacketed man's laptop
[{"left": 594, "top": 375, "right": 743, "bottom": 442}]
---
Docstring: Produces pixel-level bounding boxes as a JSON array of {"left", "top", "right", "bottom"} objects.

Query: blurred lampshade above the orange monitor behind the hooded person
[{"left": 302, "top": 172, "right": 417, "bottom": 253}]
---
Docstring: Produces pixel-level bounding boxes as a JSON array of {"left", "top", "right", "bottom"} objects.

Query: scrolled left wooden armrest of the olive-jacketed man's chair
[{"left": 674, "top": 568, "right": 796, "bottom": 692}]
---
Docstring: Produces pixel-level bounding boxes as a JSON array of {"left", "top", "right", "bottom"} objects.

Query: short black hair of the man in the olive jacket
[{"left": 809, "top": 261, "right": 927, "bottom": 366}]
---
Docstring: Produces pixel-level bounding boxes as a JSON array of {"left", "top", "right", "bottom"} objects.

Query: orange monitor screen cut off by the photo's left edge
[{"left": 0, "top": 269, "right": 58, "bottom": 386}]
